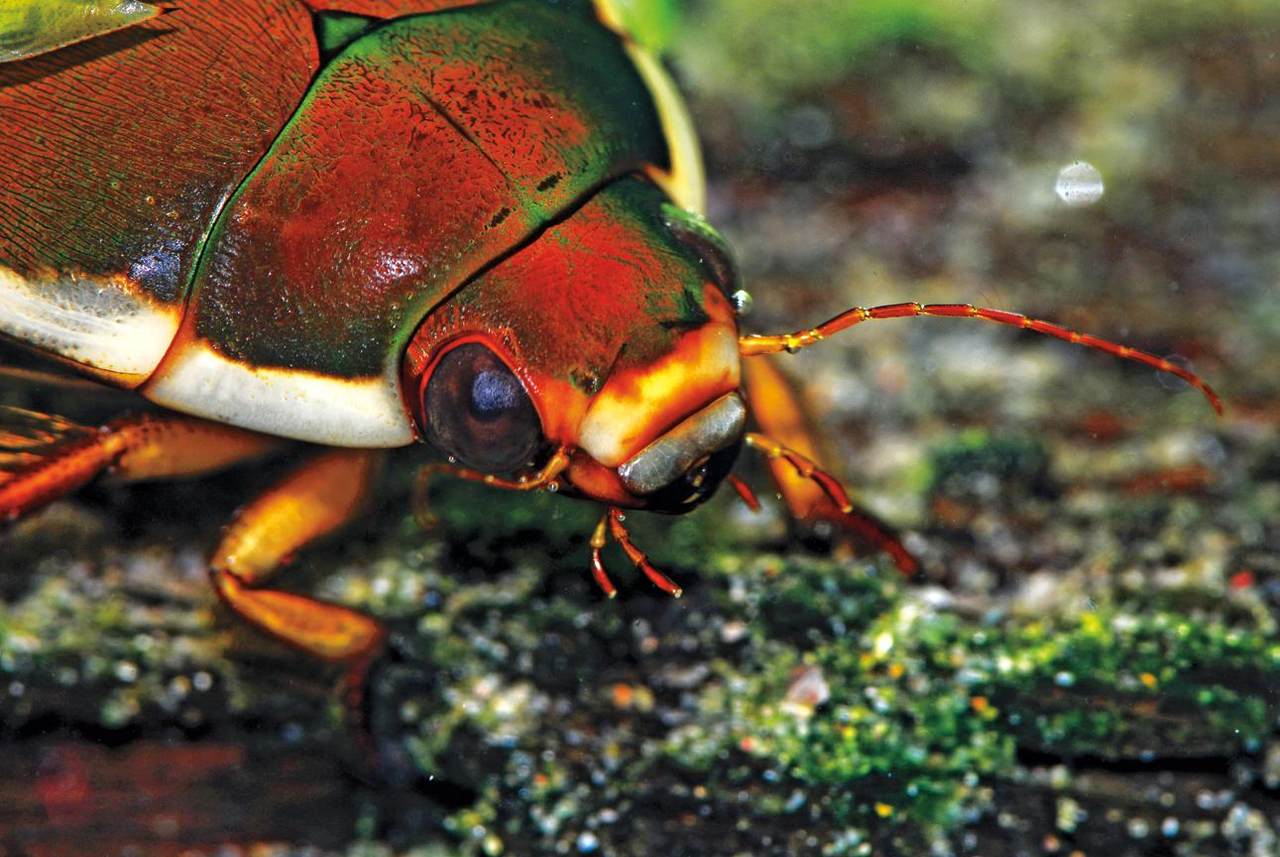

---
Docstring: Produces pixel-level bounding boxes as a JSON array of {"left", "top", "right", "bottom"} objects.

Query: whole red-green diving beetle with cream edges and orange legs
[{"left": 0, "top": 0, "right": 1220, "bottom": 695}]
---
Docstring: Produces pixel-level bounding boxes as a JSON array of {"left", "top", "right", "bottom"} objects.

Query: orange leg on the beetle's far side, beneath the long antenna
[{"left": 742, "top": 357, "right": 919, "bottom": 574}]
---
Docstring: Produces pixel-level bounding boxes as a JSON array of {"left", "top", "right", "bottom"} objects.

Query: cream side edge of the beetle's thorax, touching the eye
[{"left": 141, "top": 342, "right": 413, "bottom": 449}]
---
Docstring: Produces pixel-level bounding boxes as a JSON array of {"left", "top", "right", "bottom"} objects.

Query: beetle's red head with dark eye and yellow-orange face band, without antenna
[{"left": 403, "top": 178, "right": 746, "bottom": 512}]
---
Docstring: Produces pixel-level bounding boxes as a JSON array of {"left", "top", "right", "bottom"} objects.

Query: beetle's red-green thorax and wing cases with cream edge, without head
[{"left": 0, "top": 0, "right": 721, "bottom": 446}]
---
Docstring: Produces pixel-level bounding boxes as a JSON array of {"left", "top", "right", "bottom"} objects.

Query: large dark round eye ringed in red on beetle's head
[{"left": 422, "top": 343, "right": 545, "bottom": 473}]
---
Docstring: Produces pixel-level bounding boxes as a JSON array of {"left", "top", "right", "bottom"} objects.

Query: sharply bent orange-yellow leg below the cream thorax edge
[{"left": 209, "top": 449, "right": 385, "bottom": 711}]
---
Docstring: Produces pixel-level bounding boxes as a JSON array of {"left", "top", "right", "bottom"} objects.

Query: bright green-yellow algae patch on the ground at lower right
[{"left": 666, "top": 560, "right": 1280, "bottom": 837}]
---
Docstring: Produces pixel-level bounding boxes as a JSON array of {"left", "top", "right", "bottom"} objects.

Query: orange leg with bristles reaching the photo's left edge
[{"left": 0, "top": 414, "right": 279, "bottom": 521}]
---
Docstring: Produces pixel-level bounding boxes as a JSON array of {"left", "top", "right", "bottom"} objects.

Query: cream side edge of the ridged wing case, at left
[{"left": 0, "top": 266, "right": 180, "bottom": 380}]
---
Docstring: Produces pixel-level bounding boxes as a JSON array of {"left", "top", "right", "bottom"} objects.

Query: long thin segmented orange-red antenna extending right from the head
[{"left": 739, "top": 302, "right": 1222, "bottom": 414}]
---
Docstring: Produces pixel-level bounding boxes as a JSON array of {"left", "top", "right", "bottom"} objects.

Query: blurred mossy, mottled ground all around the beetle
[{"left": 0, "top": 0, "right": 1280, "bottom": 857}]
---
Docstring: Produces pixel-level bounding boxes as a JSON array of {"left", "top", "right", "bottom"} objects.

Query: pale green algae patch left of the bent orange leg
[{"left": 0, "top": 539, "right": 250, "bottom": 729}]
